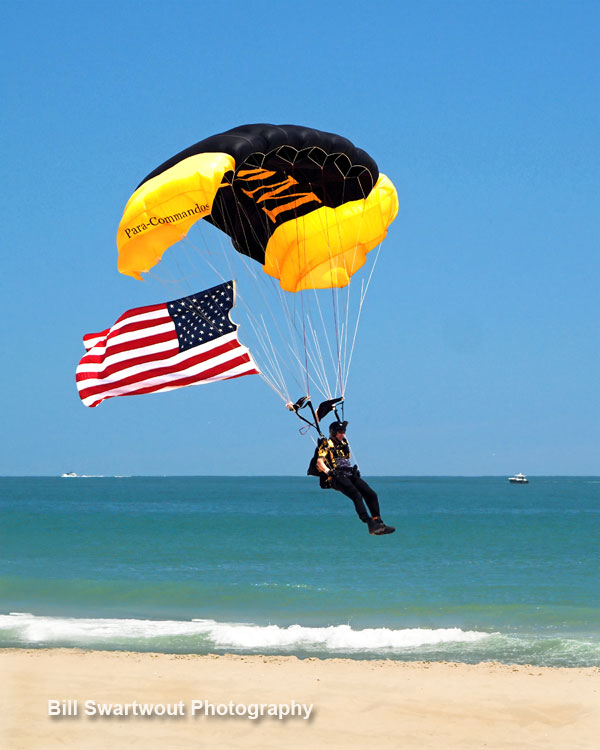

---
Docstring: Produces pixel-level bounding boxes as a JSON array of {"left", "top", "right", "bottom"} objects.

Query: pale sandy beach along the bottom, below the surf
[{"left": 0, "top": 649, "right": 600, "bottom": 750}]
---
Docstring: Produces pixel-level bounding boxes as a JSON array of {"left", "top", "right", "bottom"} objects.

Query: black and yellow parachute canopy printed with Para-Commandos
[{"left": 117, "top": 124, "right": 398, "bottom": 292}]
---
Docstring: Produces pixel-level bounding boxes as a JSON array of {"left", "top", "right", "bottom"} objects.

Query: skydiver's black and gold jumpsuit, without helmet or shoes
[{"left": 317, "top": 438, "right": 379, "bottom": 523}]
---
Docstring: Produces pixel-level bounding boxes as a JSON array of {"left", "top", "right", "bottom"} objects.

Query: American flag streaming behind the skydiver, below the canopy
[{"left": 76, "top": 281, "right": 259, "bottom": 406}]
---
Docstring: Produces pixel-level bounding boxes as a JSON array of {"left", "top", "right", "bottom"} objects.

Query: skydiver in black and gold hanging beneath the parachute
[{"left": 309, "top": 421, "right": 396, "bottom": 536}]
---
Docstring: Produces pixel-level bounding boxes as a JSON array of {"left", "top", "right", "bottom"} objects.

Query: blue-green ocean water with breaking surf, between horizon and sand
[{"left": 0, "top": 477, "right": 600, "bottom": 666}]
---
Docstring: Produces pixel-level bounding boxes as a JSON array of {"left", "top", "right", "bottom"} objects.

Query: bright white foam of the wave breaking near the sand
[{"left": 0, "top": 613, "right": 490, "bottom": 652}]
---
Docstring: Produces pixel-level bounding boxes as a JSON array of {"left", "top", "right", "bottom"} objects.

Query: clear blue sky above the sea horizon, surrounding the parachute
[{"left": 0, "top": 0, "right": 600, "bottom": 481}]
